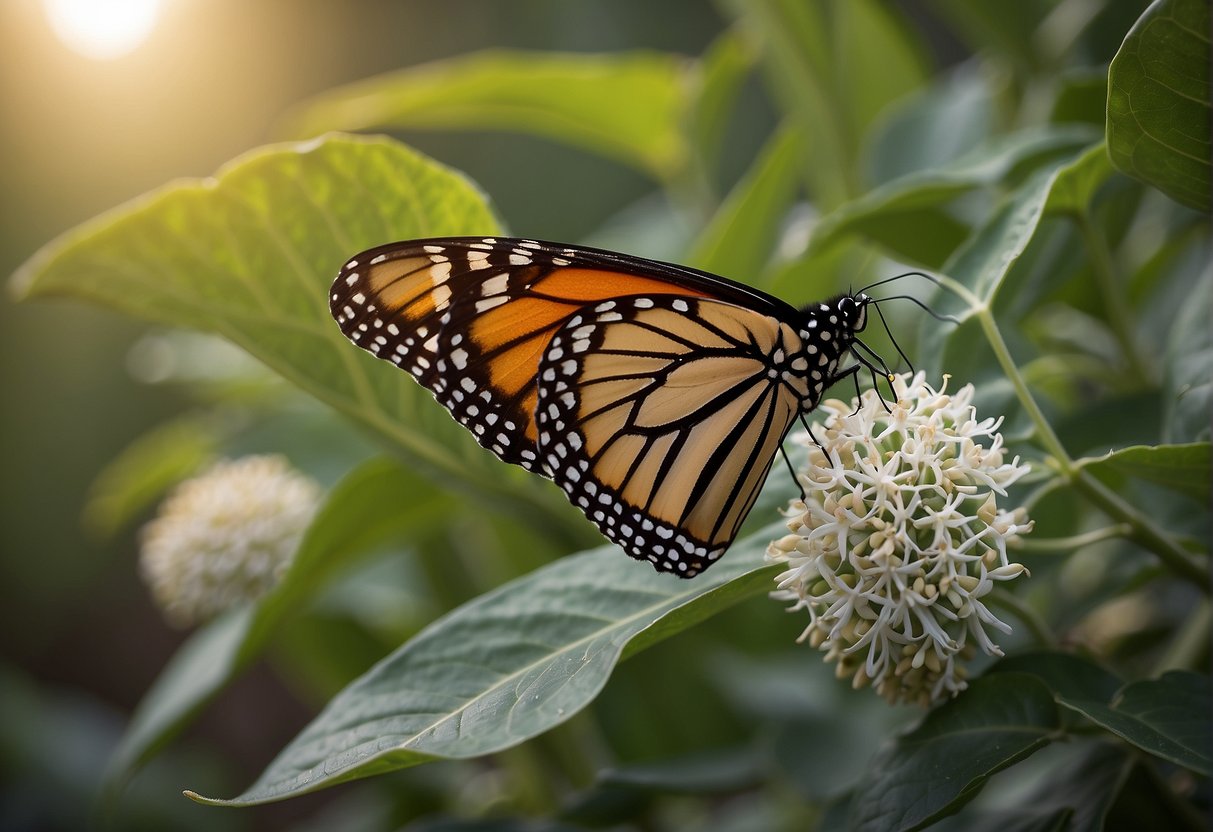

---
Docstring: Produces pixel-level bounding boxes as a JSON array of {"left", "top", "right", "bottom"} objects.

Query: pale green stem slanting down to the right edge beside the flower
[{"left": 940, "top": 278, "right": 1211, "bottom": 593}]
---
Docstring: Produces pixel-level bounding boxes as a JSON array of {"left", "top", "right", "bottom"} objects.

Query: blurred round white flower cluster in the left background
[{"left": 139, "top": 455, "right": 321, "bottom": 626}]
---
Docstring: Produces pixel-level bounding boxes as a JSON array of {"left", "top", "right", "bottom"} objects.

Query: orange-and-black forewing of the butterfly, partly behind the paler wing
[{"left": 330, "top": 238, "right": 790, "bottom": 473}]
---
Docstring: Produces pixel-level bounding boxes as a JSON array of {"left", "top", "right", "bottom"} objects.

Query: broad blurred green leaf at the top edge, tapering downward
[{"left": 724, "top": 0, "right": 926, "bottom": 207}]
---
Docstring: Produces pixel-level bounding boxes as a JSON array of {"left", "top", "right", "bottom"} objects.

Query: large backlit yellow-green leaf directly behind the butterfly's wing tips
[{"left": 13, "top": 136, "right": 565, "bottom": 528}]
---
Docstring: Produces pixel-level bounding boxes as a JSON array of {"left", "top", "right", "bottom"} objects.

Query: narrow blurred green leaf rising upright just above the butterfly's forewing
[{"left": 688, "top": 127, "right": 804, "bottom": 284}]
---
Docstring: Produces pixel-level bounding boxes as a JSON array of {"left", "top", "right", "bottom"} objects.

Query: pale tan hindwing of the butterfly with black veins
[{"left": 536, "top": 296, "right": 801, "bottom": 577}]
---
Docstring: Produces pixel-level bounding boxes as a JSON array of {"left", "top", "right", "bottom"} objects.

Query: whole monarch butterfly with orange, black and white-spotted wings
[{"left": 330, "top": 237, "right": 902, "bottom": 577}]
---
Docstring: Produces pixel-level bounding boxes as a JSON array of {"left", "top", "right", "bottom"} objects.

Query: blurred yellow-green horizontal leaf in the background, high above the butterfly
[{"left": 282, "top": 50, "right": 695, "bottom": 179}]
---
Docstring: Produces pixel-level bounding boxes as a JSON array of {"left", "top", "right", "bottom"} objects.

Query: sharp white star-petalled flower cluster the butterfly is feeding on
[{"left": 767, "top": 372, "right": 1032, "bottom": 705}]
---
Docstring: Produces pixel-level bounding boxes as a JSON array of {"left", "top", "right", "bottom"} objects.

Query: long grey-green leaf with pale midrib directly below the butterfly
[{"left": 190, "top": 524, "right": 782, "bottom": 805}]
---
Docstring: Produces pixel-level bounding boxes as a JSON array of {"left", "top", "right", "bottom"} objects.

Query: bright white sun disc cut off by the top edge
[{"left": 42, "top": 0, "right": 161, "bottom": 61}]
